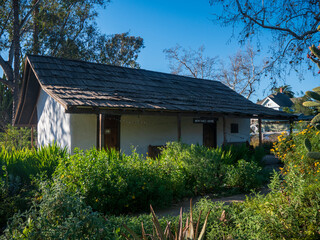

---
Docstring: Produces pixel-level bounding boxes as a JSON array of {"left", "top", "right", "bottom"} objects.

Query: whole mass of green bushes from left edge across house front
[{"left": 0, "top": 143, "right": 268, "bottom": 239}]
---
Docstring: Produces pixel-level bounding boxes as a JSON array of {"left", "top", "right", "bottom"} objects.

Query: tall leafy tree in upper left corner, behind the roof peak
[{"left": 0, "top": 0, "right": 104, "bottom": 119}]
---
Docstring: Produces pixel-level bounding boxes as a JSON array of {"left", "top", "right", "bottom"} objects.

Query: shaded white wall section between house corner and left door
[{"left": 71, "top": 114, "right": 97, "bottom": 152}]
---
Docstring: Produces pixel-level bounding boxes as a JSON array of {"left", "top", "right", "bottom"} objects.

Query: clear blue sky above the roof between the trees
[{"left": 97, "top": 0, "right": 320, "bottom": 101}]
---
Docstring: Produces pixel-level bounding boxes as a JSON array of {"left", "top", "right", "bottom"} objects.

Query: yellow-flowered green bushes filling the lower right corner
[{"left": 113, "top": 130, "right": 320, "bottom": 239}]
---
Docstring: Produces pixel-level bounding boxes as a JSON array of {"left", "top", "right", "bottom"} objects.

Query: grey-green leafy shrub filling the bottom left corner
[{"left": 2, "top": 180, "right": 115, "bottom": 239}]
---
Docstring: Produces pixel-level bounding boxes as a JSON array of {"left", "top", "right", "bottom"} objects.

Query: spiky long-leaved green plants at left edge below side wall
[{"left": 0, "top": 145, "right": 67, "bottom": 232}]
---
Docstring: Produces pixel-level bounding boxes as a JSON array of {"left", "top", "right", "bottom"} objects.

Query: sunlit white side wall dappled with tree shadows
[{"left": 37, "top": 89, "right": 71, "bottom": 150}]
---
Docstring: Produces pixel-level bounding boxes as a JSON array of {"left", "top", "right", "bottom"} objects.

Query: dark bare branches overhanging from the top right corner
[{"left": 210, "top": 0, "right": 320, "bottom": 77}]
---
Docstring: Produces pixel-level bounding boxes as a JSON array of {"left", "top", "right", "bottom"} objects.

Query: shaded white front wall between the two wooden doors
[{"left": 120, "top": 115, "right": 202, "bottom": 154}]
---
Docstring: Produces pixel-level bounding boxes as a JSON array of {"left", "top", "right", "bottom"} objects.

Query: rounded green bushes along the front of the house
[{"left": 55, "top": 143, "right": 261, "bottom": 213}]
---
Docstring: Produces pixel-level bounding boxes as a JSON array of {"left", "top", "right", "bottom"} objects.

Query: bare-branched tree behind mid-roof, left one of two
[{"left": 163, "top": 45, "right": 218, "bottom": 79}]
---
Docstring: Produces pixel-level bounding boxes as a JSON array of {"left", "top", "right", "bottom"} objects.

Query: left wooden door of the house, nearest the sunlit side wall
[{"left": 104, "top": 116, "right": 120, "bottom": 150}]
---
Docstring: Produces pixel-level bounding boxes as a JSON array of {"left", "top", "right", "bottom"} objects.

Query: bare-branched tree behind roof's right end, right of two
[{"left": 218, "top": 45, "right": 267, "bottom": 99}]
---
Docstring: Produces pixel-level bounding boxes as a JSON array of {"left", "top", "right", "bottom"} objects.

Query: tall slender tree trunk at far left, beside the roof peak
[{"left": 12, "top": 0, "right": 20, "bottom": 121}]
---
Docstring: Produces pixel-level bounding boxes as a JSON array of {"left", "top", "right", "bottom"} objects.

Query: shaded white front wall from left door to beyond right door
[{"left": 120, "top": 115, "right": 250, "bottom": 154}]
